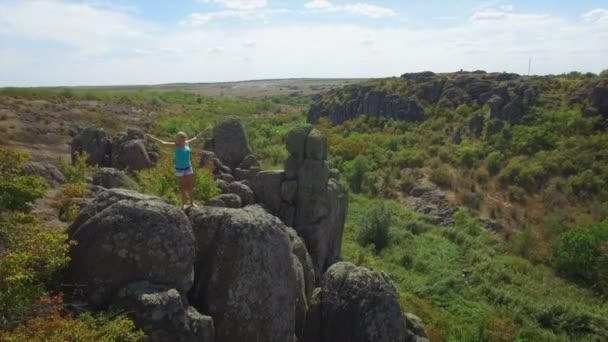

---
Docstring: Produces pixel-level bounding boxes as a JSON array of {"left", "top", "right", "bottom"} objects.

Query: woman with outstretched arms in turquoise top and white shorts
[{"left": 147, "top": 128, "right": 209, "bottom": 209}]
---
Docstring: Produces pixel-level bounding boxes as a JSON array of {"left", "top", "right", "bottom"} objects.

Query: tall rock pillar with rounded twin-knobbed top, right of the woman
[{"left": 253, "top": 125, "right": 348, "bottom": 276}]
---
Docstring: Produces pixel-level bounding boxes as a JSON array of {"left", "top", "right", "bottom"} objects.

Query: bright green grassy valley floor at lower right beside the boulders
[{"left": 342, "top": 195, "right": 608, "bottom": 341}]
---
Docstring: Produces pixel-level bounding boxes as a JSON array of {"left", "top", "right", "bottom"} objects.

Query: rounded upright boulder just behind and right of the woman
[{"left": 209, "top": 117, "right": 251, "bottom": 169}]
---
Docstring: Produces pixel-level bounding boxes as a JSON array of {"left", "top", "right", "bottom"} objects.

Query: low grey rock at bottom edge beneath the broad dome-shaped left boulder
[{"left": 111, "top": 281, "right": 215, "bottom": 342}]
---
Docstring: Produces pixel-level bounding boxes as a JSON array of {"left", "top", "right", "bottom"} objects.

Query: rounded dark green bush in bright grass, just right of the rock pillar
[{"left": 359, "top": 202, "right": 392, "bottom": 252}]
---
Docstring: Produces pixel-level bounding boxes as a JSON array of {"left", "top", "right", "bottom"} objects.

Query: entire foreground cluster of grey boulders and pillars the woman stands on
[{"left": 65, "top": 119, "right": 426, "bottom": 342}]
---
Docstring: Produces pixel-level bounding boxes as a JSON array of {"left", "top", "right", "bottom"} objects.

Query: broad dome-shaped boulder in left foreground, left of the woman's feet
[{"left": 67, "top": 191, "right": 194, "bottom": 308}]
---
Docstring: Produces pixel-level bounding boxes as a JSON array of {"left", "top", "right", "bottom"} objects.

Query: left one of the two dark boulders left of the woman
[{"left": 70, "top": 127, "right": 112, "bottom": 166}]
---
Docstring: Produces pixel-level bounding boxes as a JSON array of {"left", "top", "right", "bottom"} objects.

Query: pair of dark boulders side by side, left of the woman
[{"left": 71, "top": 127, "right": 159, "bottom": 171}]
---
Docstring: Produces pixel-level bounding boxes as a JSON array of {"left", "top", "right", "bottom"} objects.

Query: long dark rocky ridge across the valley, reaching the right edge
[{"left": 307, "top": 71, "right": 608, "bottom": 125}]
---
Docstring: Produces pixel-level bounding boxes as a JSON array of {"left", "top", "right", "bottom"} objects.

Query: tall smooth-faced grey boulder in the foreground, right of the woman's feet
[{"left": 189, "top": 205, "right": 301, "bottom": 342}]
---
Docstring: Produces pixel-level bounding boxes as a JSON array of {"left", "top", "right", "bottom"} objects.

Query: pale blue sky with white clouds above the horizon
[{"left": 0, "top": 0, "right": 608, "bottom": 87}]
